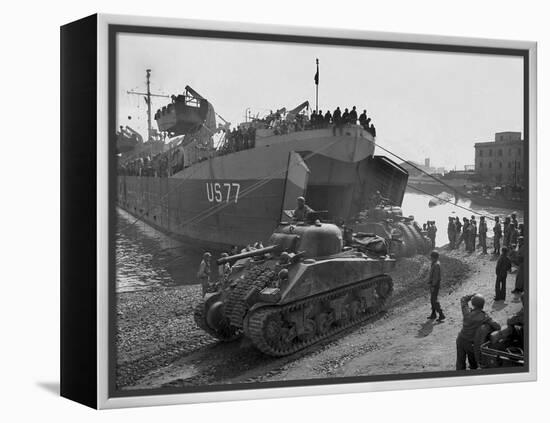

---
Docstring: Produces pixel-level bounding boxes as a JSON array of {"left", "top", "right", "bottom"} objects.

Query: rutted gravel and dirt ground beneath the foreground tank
[{"left": 117, "top": 250, "right": 521, "bottom": 389}]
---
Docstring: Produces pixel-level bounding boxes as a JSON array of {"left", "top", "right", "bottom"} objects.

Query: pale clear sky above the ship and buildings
[{"left": 117, "top": 34, "right": 523, "bottom": 170}]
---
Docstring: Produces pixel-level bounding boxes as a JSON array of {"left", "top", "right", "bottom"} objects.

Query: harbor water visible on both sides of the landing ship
[{"left": 116, "top": 192, "right": 523, "bottom": 292}]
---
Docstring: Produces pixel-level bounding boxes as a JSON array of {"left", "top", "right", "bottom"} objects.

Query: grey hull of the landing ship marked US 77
[{"left": 117, "top": 127, "right": 406, "bottom": 250}]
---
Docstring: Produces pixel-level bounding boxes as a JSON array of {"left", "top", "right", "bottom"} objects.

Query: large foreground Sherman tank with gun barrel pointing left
[{"left": 195, "top": 221, "right": 395, "bottom": 356}]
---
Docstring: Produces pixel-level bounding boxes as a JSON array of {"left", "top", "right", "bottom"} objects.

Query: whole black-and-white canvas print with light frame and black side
[{"left": 61, "top": 15, "right": 537, "bottom": 408}]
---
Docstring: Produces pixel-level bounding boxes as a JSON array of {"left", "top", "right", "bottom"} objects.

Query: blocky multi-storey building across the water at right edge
[{"left": 475, "top": 131, "right": 524, "bottom": 185}]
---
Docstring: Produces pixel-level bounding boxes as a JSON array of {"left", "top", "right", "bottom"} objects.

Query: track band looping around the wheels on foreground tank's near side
[{"left": 245, "top": 275, "right": 393, "bottom": 357}]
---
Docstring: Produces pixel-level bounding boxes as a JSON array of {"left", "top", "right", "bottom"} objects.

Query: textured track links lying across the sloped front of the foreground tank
[{"left": 225, "top": 264, "right": 275, "bottom": 328}]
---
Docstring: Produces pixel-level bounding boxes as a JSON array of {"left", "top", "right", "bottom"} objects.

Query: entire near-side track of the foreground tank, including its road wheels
[{"left": 244, "top": 275, "right": 393, "bottom": 357}]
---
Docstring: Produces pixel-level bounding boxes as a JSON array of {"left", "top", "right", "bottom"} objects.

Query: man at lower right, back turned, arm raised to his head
[{"left": 456, "top": 294, "right": 500, "bottom": 370}]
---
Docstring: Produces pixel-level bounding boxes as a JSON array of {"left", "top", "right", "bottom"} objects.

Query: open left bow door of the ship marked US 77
[{"left": 280, "top": 151, "right": 309, "bottom": 222}]
